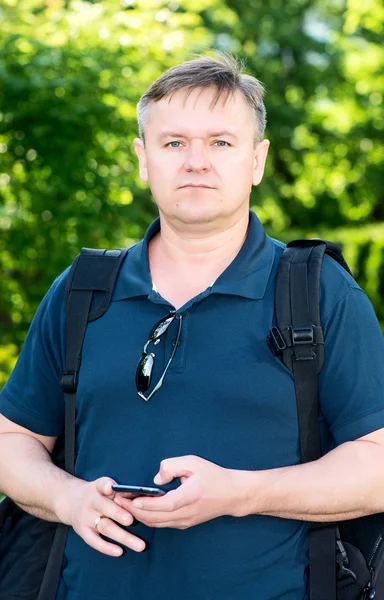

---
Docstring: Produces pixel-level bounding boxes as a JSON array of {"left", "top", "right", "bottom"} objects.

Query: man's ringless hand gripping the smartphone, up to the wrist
[{"left": 119, "top": 456, "right": 236, "bottom": 529}]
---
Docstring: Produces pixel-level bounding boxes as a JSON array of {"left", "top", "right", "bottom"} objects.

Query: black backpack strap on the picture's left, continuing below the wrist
[{"left": 37, "top": 248, "right": 128, "bottom": 600}]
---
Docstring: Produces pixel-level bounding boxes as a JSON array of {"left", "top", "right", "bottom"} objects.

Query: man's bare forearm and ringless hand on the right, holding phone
[{"left": 124, "top": 429, "right": 384, "bottom": 529}]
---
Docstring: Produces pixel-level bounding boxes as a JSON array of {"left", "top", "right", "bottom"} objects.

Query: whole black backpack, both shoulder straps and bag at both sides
[{"left": 0, "top": 240, "right": 384, "bottom": 600}]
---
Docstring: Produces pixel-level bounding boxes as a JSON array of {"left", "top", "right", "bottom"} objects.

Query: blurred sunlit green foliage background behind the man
[{"left": 0, "top": 0, "right": 384, "bottom": 387}]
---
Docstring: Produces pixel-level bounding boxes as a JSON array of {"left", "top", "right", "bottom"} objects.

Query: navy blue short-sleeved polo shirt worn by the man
[{"left": 0, "top": 212, "right": 384, "bottom": 600}]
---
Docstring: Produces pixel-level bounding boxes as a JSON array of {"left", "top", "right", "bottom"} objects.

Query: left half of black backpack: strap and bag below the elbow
[{"left": 0, "top": 248, "right": 127, "bottom": 600}]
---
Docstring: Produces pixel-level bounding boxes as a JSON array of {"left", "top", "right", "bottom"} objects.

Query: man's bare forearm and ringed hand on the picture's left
[{"left": 0, "top": 415, "right": 145, "bottom": 556}]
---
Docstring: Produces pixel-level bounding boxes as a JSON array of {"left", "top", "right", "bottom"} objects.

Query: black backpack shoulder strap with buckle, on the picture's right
[{"left": 268, "top": 241, "right": 326, "bottom": 462}]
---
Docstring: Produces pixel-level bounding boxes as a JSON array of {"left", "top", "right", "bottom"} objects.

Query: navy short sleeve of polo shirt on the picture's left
[{"left": 0, "top": 270, "right": 69, "bottom": 436}]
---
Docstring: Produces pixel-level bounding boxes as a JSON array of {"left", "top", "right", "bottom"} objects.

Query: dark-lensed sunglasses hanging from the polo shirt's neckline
[{"left": 136, "top": 314, "right": 183, "bottom": 402}]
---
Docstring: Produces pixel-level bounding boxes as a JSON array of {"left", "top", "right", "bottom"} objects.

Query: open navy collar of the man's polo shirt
[{"left": 113, "top": 211, "right": 275, "bottom": 300}]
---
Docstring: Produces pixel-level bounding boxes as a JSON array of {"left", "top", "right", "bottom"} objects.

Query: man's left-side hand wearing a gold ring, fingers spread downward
[{"left": 56, "top": 477, "right": 145, "bottom": 556}]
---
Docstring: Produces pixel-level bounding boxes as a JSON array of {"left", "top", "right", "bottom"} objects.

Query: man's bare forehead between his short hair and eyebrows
[{"left": 148, "top": 88, "right": 252, "bottom": 135}]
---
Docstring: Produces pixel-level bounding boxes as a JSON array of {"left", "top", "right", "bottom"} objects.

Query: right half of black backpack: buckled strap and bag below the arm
[{"left": 267, "top": 240, "right": 384, "bottom": 600}]
